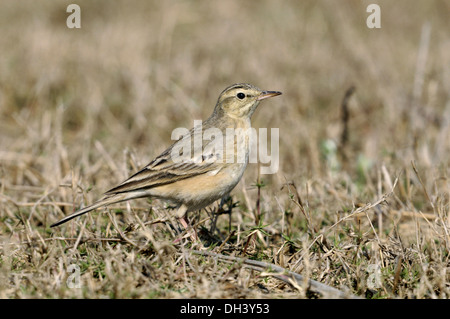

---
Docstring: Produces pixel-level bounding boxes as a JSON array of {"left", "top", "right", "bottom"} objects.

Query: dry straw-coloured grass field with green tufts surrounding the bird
[{"left": 0, "top": 0, "right": 450, "bottom": 298}]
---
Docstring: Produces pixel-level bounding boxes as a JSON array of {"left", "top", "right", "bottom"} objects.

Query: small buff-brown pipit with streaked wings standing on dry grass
[{"left": 51, "top": 83, "right": 281, "bottom": 228}]
